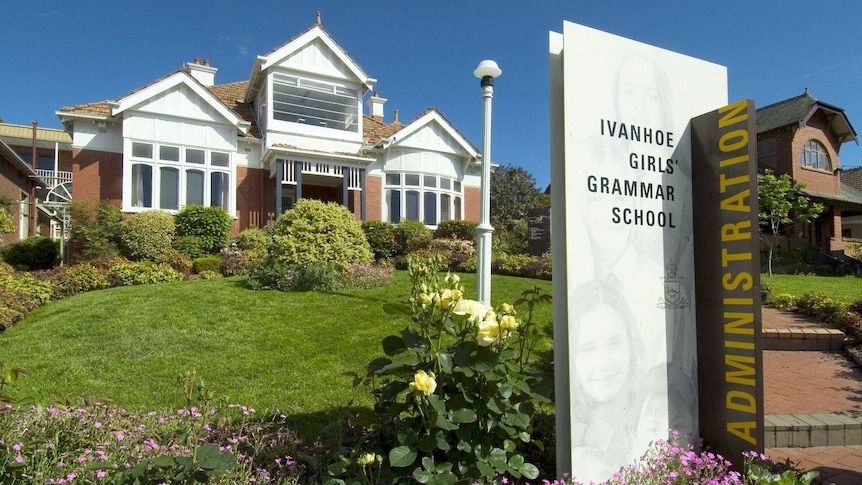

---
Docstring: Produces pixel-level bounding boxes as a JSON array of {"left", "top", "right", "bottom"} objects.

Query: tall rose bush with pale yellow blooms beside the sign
[{"left": 329, "top": 256, "right": 547, "bottom": 484}]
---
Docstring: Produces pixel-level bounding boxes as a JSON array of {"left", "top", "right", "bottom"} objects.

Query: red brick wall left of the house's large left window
[{"left": 72, "top": 148, "right": 123, "bottom": 206}]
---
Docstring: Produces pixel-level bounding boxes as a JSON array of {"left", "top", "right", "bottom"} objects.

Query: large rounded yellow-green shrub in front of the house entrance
[{"left": 272, "top": 199, "right": 373, "bottom": 271}]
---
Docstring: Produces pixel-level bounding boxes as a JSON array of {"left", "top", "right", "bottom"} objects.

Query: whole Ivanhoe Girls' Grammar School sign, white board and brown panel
[{"left": 550, "top": 22, "right": 763, "bottom": 482}]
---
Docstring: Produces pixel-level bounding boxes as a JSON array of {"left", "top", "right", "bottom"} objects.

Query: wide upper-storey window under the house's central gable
[{"left": 272, "top": 74, "right": 359, "bottom": 133}]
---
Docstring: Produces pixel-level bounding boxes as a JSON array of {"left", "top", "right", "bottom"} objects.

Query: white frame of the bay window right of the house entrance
[{"left": 382, "top": 171, "right": 464, "bottom": 228}]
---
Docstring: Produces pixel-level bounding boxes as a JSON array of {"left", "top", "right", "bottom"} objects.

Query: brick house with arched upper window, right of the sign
[{"left": 757, "top": 89, "right": 862, "bottom": 256}]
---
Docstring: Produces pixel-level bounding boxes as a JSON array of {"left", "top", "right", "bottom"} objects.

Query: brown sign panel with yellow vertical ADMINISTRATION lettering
[{"left": 691, "top": 100, "right": 764, "bottom": 468}]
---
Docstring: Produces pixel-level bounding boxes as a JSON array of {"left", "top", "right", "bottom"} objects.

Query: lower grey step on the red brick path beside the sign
[{"left": 763, "top": 411, "right": 862, "bottom": 448}]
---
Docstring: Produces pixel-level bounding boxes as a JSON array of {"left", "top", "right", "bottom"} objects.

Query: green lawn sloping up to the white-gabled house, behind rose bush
[{"left": 0, "top": 271, "right": 553, "bottom": 432}]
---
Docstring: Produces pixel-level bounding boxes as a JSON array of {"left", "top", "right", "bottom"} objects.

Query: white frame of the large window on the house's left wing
[{"left": 123, "top": 138, "right": 237, "bottom": 218}]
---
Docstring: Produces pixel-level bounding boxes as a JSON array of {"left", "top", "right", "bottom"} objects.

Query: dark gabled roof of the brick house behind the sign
[{"left": 757, "top": 89, "right": 859, "bottom": 143}]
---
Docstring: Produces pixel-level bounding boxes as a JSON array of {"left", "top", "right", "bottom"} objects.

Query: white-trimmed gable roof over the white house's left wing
[{"left": 57, "top": 70, "right": 251, "bottom": 134}]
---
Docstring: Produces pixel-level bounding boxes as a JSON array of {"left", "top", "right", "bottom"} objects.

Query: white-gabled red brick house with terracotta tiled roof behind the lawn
[{"left": 57, "top": 18, "right": 481, "bottom": 232}]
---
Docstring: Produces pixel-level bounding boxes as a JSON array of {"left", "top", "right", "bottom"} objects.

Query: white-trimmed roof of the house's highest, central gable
[{"left": 243, "top": 22, "right": 377, "bottom": 102}]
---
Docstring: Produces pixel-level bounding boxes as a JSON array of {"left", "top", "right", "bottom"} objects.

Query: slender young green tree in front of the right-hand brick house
[{"left": 757, "top": 170, "right": 823, "bottom": 276}]
